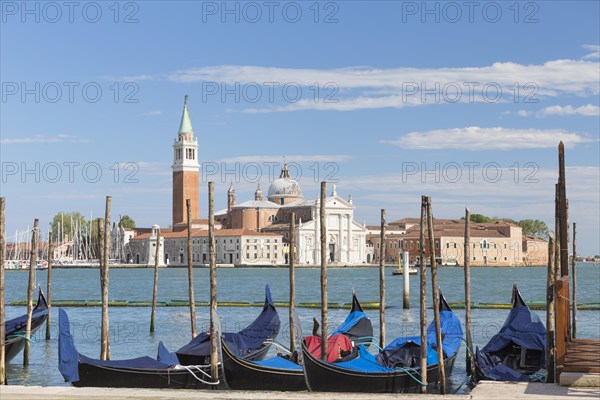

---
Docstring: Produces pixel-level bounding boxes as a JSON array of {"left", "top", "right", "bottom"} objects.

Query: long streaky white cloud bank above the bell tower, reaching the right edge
[{"left": 115, "top": 54, "right": 600, "bottom": 113}]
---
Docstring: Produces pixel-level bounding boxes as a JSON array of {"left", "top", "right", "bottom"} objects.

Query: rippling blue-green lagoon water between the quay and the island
[{"left": 6, "top": 263, "right": 600, "bottom": 390}]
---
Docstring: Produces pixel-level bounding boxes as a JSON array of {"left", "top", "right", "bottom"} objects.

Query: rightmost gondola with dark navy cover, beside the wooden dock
[{"left": 475, "top": 285, "right": 546, "bottom": 382}]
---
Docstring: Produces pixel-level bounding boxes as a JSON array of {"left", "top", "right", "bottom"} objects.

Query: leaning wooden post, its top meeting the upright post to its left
[{"left": 427, "top": 196, "right": 446, "bottom": 395}]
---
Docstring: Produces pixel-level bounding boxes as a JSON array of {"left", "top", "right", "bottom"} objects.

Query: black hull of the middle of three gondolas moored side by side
[{"left": 222, "top": 344, "right": 308, "bottom": 391}]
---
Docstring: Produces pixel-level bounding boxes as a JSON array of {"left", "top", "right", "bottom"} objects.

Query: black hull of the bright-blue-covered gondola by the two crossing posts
[{"left": 302, "top": 346, "right": 456, "bottom": 393}]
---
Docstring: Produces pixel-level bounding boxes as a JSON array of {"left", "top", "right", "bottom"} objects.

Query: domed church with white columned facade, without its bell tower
[{"left": 216, "top": 170, "right": 368, "bottom": 265}]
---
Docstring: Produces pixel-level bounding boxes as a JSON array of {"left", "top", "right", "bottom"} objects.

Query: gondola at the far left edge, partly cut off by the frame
[{"left": 4, "top": 288, "right": 48, "bottom": 361}]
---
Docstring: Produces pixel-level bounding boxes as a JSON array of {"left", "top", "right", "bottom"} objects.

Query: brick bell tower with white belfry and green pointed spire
[{"left": 172, "top": 95, "right": 200, "bottom": 227}]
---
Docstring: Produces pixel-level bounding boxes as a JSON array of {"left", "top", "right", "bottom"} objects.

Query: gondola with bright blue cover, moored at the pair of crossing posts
[{"left": 302, "top": 292, "right": 463, "bottom": 393}]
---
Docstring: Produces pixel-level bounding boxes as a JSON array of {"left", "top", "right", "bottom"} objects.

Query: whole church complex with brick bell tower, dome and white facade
[{"left": 123, "top": 96, "right": 368, "bottom": 266}]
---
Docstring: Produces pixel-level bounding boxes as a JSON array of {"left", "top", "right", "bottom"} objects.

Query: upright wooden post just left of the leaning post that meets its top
[{"left": 418, "top": 196, "right": 427, "bottom": 393}]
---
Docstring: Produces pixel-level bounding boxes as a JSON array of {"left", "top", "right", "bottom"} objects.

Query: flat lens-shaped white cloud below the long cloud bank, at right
[{"left": 382, "top": 126, "right": 592, "bottom": 151}]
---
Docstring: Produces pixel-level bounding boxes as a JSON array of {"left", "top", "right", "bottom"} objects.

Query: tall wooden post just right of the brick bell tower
[{"left": 208, "top": 182, "right": 219, "bottom": 389}]
